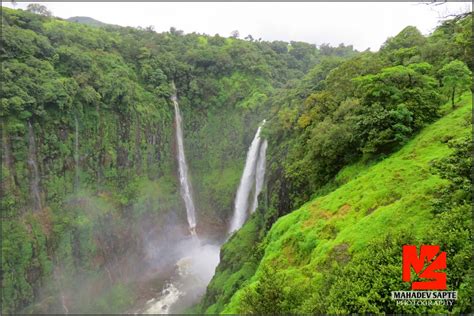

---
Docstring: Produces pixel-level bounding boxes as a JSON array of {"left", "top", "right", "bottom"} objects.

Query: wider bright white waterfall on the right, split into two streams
[{"left": 229, "top": 120, "right": 267, "bottom": 233}]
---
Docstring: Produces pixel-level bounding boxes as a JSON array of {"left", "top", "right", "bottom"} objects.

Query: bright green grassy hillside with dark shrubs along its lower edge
[{"left": 203, "top": 95, "right": 472, "bottom": 314}]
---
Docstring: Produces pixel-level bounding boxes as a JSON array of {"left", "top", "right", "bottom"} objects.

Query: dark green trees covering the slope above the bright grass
[{"left": 265, "top": 20, "right": 472, "bottom": 215}]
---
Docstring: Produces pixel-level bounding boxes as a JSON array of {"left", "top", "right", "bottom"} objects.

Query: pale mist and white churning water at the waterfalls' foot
[{"left": 25, "top": 190, "right": 222, "bottom": 314}]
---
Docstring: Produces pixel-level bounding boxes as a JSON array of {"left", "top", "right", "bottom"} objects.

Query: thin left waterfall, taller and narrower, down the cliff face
[{"left": 171, "top": 82, "right": 196, "bottom": 235}]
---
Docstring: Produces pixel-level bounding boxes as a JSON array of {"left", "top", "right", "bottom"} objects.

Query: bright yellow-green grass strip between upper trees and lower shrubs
[{"left": 223, "top": 95, "right": 472, "bottom": 313}]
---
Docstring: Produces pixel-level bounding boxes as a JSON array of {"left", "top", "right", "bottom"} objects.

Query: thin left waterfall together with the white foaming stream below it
[{"left": 137, "top": 86, "right": 220, "bottom": 314}]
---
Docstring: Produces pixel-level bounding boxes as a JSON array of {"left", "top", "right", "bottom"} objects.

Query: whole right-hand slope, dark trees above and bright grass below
[{"left": 198, "top": 13, "right": 473, "bottom": 313}]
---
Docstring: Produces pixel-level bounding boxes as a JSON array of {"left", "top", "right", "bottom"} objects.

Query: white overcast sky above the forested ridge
[{"left": 2, "top": 2, "right": 472, "bottom": 50}]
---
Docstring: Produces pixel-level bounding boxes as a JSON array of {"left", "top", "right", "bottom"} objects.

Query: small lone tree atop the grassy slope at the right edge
[{"left": 439, "top": 60, "right": 472, "bottom": 108}]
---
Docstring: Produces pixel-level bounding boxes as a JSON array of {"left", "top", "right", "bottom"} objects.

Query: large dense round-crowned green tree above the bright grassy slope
[{"left": 354, "top": 63, "right": 442, "bottom": 153}]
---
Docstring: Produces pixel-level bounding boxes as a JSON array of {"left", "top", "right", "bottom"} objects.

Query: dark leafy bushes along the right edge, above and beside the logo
[{"left": 425, "top": 136, "right": 474, "bottom": 314}]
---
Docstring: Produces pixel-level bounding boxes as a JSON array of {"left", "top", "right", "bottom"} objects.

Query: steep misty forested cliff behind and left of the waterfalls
[{"left": 1, "top": 7, "right": 355, "bottom": 313}]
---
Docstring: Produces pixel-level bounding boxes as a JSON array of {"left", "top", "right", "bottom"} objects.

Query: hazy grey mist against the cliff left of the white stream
[{"left": 25, "top": 189, "right": 196, "bottom": 314}]
